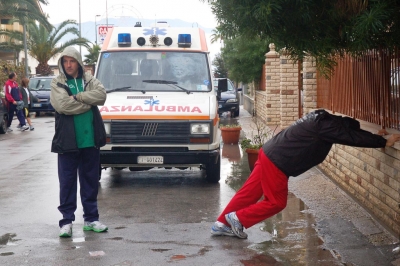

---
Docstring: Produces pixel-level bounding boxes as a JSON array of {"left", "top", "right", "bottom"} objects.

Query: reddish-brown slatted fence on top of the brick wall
[{"left": 317, "top": 50, "right": 400, "bottom": 129}]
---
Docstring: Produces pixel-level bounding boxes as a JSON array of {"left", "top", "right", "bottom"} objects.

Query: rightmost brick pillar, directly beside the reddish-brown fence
[{"left": 303, "top": 56, "right": 317, "bottom": 114}]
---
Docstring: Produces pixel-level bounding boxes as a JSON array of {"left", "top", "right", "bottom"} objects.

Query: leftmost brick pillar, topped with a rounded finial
[{"left": 265, "top": 43, "right": 281, "bottom": 125}]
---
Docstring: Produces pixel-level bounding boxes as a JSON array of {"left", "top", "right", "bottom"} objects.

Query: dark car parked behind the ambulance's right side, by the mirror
[{"left": 213, "top": 78, "right": 240, "bottom": 117}]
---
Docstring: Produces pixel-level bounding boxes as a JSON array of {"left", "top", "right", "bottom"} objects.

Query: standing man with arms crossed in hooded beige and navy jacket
[{"left": 50, "top": 47, "right": 108, "bottom": 237}]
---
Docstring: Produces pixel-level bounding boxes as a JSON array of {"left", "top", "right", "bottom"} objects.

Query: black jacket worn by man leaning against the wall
[{"left": 262, "top": 110, "right": 386, "bottom": 177}]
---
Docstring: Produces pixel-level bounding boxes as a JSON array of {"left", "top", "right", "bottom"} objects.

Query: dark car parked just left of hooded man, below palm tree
[{"left": 29, "top": 76, "right": 54, "bottom": 116}]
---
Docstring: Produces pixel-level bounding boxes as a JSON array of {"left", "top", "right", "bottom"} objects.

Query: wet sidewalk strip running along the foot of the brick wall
[{"left": 238, "top": 109, "right": 400, "bottom": 265}]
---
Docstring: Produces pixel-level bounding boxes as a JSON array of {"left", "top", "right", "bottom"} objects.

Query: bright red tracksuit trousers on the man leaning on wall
[{"left": 217, "top": 149, "right": 289, "bottom": 228}]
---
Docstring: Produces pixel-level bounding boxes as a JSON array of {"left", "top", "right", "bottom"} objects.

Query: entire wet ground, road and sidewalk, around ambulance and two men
[{"left": 0, "top": 110, "right": 400, "bottom": 266}]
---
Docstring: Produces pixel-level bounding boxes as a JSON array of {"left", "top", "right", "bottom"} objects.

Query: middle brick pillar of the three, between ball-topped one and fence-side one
[{"left": 280, "top": 50, "right": 299, "bottom": 128}]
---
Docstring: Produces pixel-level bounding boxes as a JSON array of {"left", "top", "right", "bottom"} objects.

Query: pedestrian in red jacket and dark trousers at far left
[{"left": 4, "top": 72, "right": 29, "bottom": 132}]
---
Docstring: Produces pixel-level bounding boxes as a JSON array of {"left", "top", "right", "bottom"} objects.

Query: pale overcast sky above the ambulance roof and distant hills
[{"left": 42, "top": 0, "right": 221, "bottom": 58}]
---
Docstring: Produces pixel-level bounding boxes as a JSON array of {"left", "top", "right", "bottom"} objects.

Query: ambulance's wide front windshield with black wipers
[{"left": 97, "top": 51, "right": 212, "bottom": 92}]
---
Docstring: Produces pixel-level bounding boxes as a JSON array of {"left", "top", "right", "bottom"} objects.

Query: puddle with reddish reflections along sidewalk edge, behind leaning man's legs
[{"left": 221, "top": 145, "right": 341, "bottom": 266}]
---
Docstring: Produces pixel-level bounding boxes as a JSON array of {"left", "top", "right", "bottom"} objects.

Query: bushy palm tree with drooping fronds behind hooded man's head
[{"left": 28, "top": 20, "right": 90, "bottom": 75}]
